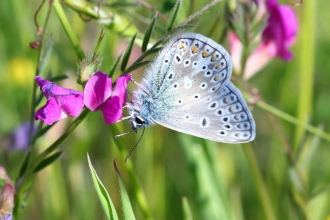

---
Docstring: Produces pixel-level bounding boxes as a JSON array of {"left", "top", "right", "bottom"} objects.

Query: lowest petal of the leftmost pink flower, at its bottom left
[{"left": 34, "top": 98, "right": 65, "bottom": 125}]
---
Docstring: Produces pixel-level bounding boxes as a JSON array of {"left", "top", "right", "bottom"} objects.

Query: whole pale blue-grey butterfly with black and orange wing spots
[{"left": 126, "top": 33, "right": 256, "bottom": 143}]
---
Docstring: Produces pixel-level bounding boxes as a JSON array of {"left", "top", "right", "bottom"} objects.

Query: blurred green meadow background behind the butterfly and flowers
[{"left": 0, "top": 0, "right": 330, "bottom": 220}]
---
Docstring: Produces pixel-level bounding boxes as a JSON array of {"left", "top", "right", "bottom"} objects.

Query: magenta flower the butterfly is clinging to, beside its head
[{"left": 84, "top": 72, "right": 131, "bottom": 124}]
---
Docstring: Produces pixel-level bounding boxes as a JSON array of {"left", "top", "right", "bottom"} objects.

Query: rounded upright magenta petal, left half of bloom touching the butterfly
[{"left": 84, "top": 72, "right": 112, "bottom": 111}]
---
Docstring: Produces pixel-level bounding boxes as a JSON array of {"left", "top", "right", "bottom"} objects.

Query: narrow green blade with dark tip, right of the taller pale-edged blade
[{"left": 114, "top": 161, "right": 135, "bottom": 220}]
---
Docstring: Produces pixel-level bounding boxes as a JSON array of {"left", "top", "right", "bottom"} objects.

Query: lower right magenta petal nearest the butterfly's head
[{"left": 101, "top": 96, "right": 123, "bottom": 124}]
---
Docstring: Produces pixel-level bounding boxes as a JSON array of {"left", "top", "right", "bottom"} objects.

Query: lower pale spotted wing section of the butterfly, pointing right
[{"left": 155, "top": 82, "right": 255, "bottom": 143}]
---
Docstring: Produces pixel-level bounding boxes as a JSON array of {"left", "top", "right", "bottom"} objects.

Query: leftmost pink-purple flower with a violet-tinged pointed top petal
[{"left": 34, "top": 76, "right": 84, "bottom": 125}]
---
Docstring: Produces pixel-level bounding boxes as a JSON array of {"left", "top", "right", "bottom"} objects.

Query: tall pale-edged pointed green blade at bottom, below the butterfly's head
[{"left": 87, "top": 154, "right": 119, "bottom": 220}]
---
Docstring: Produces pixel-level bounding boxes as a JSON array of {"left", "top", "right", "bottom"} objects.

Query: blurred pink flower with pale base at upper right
[{"left": 229, "top": 0, "right": 298, "bottom": 78}]
